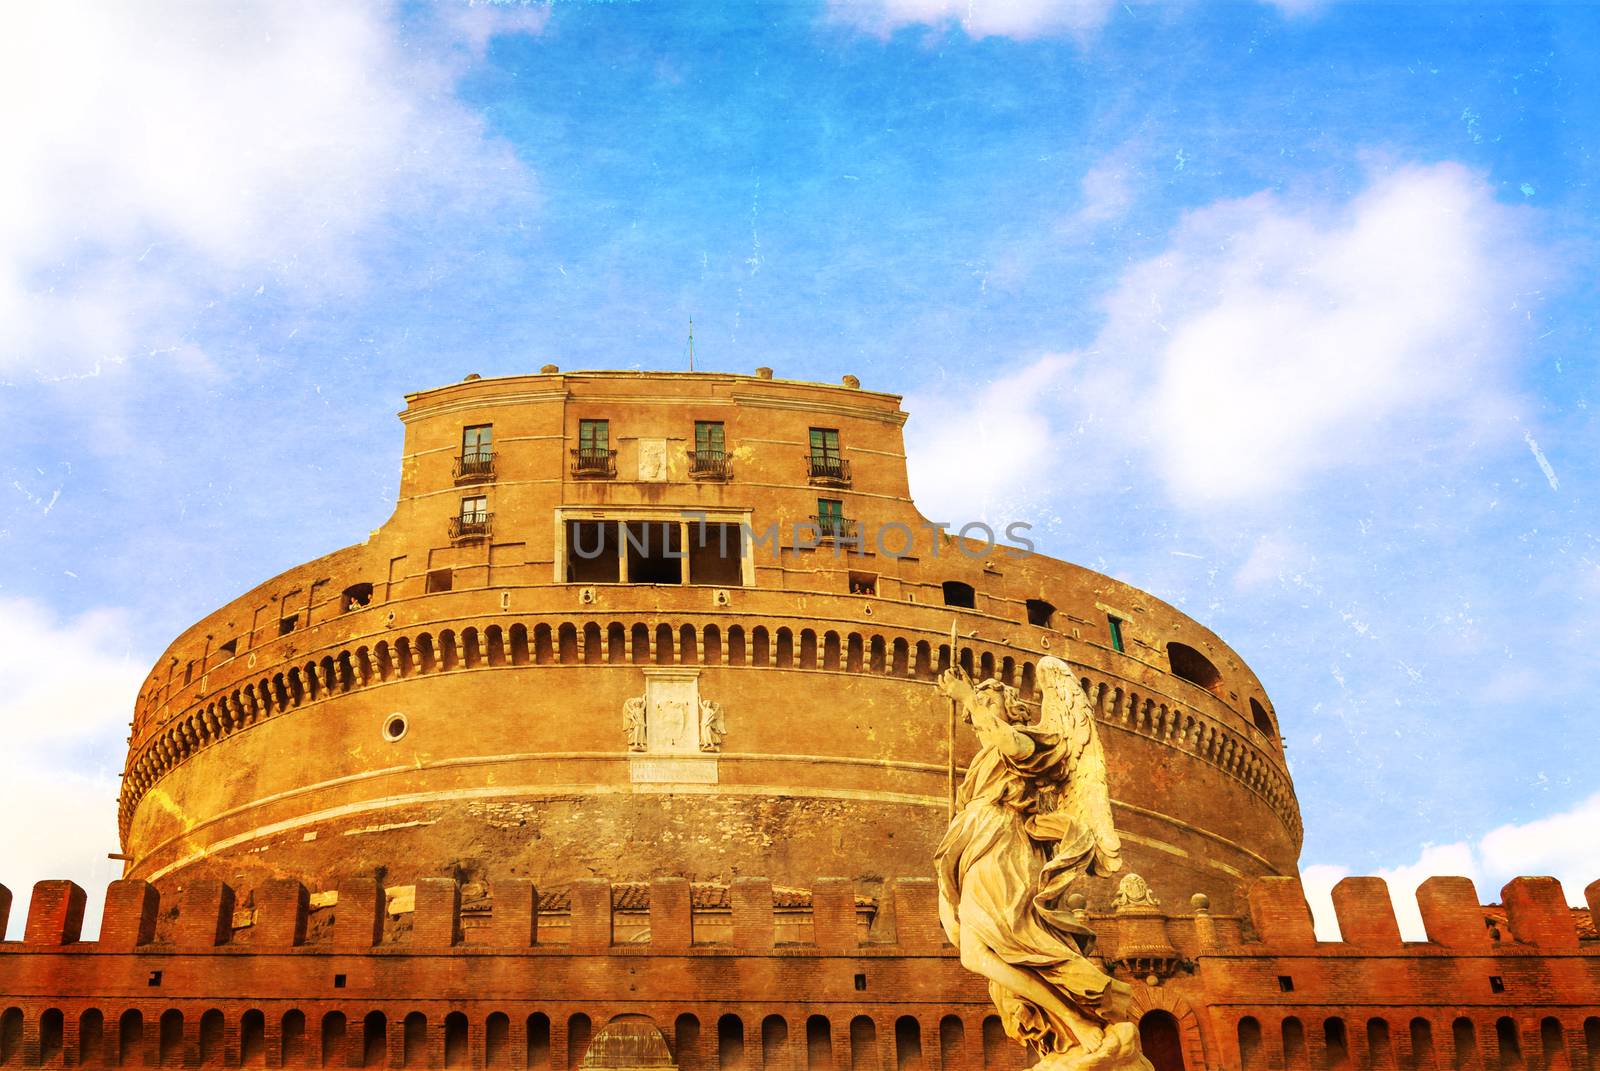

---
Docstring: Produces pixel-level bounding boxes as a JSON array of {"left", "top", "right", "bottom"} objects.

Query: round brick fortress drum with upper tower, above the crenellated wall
[{"left": 120, "top": 371, "right": 1301, "bottom": 909}]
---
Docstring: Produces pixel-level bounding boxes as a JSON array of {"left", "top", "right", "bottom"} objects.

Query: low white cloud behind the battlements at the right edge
[{"left": 1301, "top": 792, "right": 1600, "bottom": 941}]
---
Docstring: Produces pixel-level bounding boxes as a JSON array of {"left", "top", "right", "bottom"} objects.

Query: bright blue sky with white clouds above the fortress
[{"left": 0, "top": 0, "right": 1600, "bottom": 934}]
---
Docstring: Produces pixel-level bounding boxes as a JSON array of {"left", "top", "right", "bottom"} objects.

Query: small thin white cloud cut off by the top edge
[{"left": 829, "top": 0, "right": 1117, "bottom": 38}]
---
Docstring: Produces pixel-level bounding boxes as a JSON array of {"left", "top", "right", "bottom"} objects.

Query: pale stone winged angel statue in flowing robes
[{"left": 934, "top": 658, "right": 1152, "bottom": 1071}]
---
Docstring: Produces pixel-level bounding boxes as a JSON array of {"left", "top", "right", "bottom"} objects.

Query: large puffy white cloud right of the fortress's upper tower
[{"left": 902, "top": 163, "right": 1544, "bottom": 518}]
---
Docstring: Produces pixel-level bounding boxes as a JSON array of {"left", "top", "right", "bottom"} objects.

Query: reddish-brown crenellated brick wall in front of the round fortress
[{"left": 0, "top": 877, "right": 1600, "bottom": 1071}]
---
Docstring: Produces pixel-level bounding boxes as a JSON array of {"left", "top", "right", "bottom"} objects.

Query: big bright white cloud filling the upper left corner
[{"left": 0, "top": 0, "right": 542, "bottom": 368}]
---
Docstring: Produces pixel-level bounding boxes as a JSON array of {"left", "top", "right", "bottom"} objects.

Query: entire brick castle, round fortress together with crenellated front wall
[{"left": 0, "top": 367, "right": 1600, "bottom": 1071}]
